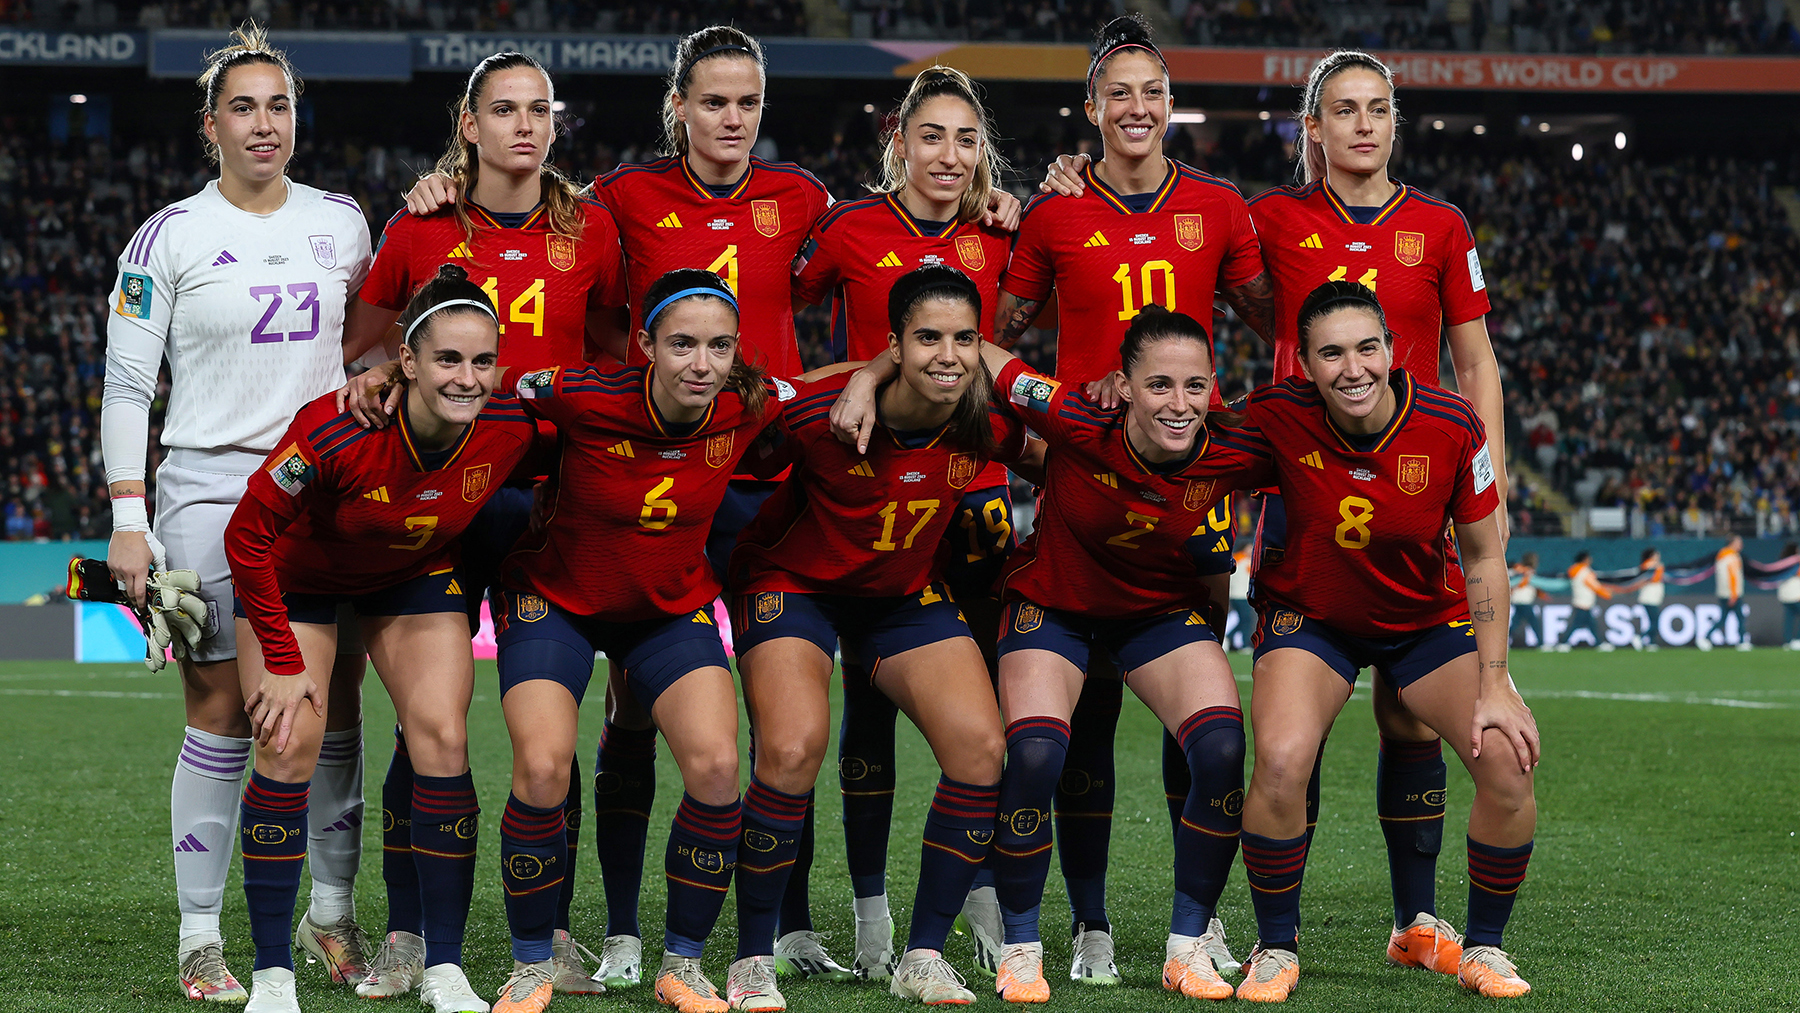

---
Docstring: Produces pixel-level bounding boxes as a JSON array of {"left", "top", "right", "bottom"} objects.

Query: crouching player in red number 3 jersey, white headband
[{"left": 225, "top": 264, "right": 536, "bottom": 1013}]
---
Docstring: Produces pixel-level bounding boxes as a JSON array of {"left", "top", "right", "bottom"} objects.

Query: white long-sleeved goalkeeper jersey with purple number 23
[{"left": 106, "top": 180, "right": 371, "bottom": 455}]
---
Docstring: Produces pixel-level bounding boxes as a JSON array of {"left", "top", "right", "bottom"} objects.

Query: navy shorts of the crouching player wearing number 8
[{"left": 1253, "top": 605, "right": 1474, "bottom": 689}]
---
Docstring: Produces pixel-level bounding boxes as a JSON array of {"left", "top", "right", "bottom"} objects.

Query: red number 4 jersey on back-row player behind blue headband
[{"left": 594, "top": 157, "right": 832, "bottom": 376}]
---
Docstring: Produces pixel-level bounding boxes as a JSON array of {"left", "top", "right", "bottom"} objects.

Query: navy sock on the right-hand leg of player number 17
[{"left": 905, "top": 775, "right": 1001, "bottom": 950}]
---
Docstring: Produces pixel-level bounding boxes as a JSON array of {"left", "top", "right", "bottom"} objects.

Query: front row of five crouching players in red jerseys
[{"left": 227, "top": 266, "right": 1537, "bottom": 1013}]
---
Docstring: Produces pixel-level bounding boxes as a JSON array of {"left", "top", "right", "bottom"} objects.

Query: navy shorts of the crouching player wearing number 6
[{"left": 495, "top": 590, "right": 731, "bottom": 711}]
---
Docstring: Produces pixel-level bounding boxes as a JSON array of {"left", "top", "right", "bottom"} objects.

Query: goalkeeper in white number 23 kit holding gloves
[{"left": 101, "top": 27, "right": 369, "bottom": 1002}]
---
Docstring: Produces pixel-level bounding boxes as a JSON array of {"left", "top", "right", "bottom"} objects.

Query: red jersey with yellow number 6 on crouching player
[{"left": 500, "top": 365, "right": 794, "bottom": 623}]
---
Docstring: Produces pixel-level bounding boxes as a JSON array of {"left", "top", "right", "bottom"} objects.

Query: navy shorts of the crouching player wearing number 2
[{"left": 999, "top": 601, "right": 1219, "bottom": 678}]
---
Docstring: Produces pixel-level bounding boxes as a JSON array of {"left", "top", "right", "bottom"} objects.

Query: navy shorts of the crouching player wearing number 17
[{"left": 731, "top": 581, "right": 968, "bottom": 678}]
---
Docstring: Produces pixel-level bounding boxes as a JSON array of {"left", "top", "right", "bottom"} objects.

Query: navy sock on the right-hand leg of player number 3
[{"left": 412, "top": 770, "right": 481, "bottom": 968}]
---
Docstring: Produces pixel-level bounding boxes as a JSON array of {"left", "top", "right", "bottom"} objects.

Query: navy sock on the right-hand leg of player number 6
[{"left": 662, "top": 792, "right": 743, "bottom": 957}]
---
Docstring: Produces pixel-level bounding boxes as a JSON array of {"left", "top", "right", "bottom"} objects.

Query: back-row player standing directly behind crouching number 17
[{"left": 792, "top": 67, "right": 1013, "bottom": 979}]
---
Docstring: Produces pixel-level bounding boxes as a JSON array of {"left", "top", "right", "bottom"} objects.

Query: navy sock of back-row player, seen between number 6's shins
[{"left": 594, "top": 723, "right": 657, "bottom": 936}]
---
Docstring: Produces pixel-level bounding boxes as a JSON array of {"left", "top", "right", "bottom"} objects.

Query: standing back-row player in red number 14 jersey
[{"left": 338, "top": 52, "right": 625, "bottom": 997}]
